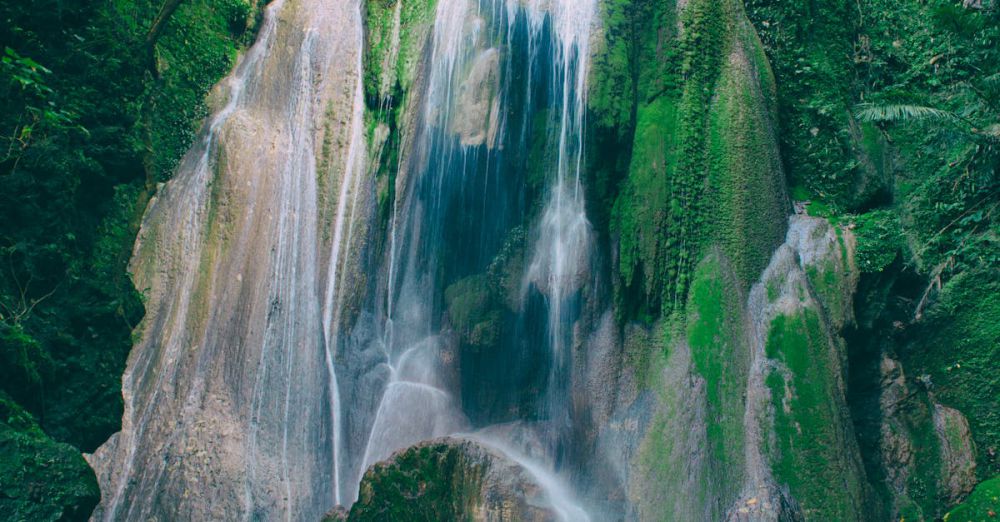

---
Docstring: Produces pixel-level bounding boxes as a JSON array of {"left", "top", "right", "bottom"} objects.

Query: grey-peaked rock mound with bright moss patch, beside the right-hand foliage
[{"left": 752, "top": 216, "right": 869, "bottom": 520}]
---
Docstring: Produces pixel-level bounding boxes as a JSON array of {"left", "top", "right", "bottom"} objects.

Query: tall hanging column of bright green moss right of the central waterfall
[{"left": 613, "top": 0, "right": 786, "bottom": 315}]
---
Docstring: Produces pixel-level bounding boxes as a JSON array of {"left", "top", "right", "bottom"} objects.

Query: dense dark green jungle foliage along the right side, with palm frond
[{"left": 746, "top": 0, "right": 1000, "bottom": 520}]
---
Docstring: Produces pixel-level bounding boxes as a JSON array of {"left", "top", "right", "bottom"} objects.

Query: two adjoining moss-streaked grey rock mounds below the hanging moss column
[{"left": 629, "top": 216, "right": 869, "bottom": 520}]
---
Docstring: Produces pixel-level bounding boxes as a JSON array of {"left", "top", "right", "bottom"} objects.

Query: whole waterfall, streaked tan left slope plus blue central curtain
[{"left": 91, "top": 0, "right": 595, "bottom": 520}]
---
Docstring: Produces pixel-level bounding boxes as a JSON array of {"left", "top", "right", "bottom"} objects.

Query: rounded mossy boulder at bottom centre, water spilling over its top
[{"left": 348, "top": 437, "right": 558, "bottom": 522}]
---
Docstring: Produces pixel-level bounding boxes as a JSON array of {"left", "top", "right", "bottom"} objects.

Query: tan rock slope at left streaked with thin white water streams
[{"left": 91, "top": 0, "right": 366, "bottom": 520}]
